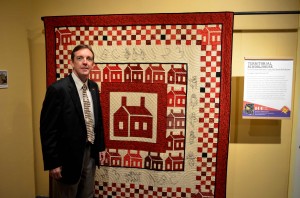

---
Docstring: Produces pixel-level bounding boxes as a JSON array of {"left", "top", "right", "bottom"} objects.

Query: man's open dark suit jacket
[{"left": 40, "top": 75, "right": 105, "bottom": 184}]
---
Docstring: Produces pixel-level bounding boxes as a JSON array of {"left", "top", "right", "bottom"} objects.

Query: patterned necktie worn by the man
[{"left": 82, "top": 84, "right": 95, "bottom": 144}]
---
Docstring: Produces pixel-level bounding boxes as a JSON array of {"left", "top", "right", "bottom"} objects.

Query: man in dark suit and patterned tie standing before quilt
[{"left": 40, "top": 45, "right": 105, "bottom": 198}]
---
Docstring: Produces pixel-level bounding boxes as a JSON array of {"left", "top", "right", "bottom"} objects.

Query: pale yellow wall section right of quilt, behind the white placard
[{"left": 227, "top": 13, "right": 299, "bottom": 198}]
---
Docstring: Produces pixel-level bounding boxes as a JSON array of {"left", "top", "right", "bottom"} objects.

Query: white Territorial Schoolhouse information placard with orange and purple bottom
[{"left": 242, "top": 59, "right": 293, "bottom": 119}]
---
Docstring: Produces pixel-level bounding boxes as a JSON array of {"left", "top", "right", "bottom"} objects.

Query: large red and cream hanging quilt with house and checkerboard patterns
[{"left": 42, "top": 12, "right": 233, "bottom": 198}]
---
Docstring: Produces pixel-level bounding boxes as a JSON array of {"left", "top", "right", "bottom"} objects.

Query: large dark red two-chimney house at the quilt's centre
[{"left": 113, "top": 96, "right": 153, "bottom": 138}]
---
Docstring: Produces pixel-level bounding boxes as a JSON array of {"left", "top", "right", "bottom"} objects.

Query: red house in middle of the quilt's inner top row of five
[{"left": 124, "top": 64, "right": 144, "bottom": 83}]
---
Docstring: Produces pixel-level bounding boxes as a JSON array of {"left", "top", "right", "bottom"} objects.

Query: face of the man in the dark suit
[{"left": 71, "top": 49, "right": 94, "bottom": 82}]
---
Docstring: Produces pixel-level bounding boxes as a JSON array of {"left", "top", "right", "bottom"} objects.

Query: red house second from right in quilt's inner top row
[{"left": 145, "top": 64, "right": 166, "bottom": 83}]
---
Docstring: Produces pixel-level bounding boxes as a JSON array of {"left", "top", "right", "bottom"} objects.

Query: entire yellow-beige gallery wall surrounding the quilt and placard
[{"left": 0, "top": 0, "right": 300, "bottom": 198}]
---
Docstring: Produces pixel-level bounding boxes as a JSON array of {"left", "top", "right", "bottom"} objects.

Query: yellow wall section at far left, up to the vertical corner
[{"left": 0, "top": 1, "right": 35, "bottom": 198}]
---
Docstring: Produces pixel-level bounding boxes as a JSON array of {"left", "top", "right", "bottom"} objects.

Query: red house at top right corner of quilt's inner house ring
[{"left": 168, "top": 64, "right": 186, "bottom": 85}]
